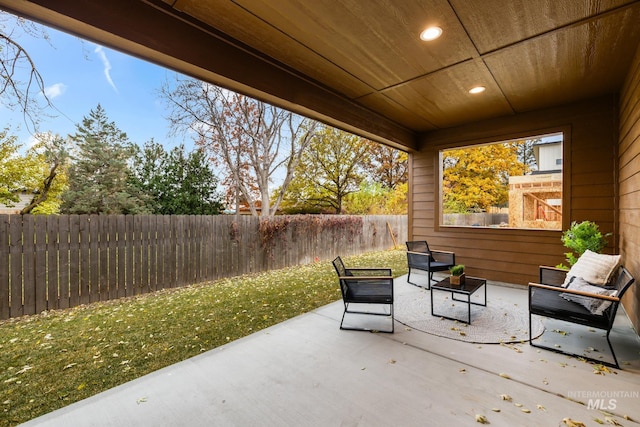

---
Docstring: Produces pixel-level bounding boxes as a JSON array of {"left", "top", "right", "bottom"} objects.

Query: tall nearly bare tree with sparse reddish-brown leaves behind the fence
[{"left": 161, "top": 77, "right": 316, "bottom": 217}]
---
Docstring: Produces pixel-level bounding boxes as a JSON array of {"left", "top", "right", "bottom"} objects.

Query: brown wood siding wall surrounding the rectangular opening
[{"left": 409, "top": 96, "right": 618, "bottom": 285}]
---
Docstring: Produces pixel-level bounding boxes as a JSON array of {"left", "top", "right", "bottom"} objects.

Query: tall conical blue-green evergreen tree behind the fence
[{"left": 61, "top": 104, "right": 148, "bottom": 214}]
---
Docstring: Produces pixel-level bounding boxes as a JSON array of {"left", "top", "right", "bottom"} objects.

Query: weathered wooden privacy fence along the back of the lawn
[{"left": 0, "top": 215, "right": 407, "bottom": 319}]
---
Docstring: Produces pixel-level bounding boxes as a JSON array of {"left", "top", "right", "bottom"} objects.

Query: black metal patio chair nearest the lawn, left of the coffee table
[{"left": 333, "top": 257, "right": 394, "bottom": 333}]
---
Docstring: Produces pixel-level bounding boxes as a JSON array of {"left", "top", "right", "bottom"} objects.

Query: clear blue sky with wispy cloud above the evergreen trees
[{"left": 0, "top": 14, "right": 192, "bottom": 149}]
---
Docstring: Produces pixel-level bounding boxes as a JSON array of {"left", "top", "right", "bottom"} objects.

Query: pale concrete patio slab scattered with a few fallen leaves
[{"left": 24, "top": 278, "right": 640, "bottom": 427}]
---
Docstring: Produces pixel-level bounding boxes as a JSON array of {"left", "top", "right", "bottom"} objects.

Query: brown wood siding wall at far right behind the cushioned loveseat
[{"left": 618, "top": 46, "right": 640, "bottom": 331}]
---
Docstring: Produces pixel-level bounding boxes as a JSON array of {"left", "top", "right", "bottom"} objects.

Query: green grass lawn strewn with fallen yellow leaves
[{"left": 0, "top": 250, "right": 407, "bottom": 426}]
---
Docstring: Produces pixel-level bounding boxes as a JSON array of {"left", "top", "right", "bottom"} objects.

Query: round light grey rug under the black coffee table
[{"left": 394, "top": 290, "right": 544, "bottom": 344}]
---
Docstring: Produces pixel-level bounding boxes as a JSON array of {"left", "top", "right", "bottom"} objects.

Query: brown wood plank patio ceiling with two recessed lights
[{"left": 0, "top": 0, "right": 640, "bottom": 149}]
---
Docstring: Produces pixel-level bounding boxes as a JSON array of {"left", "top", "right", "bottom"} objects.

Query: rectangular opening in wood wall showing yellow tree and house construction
[{"left": 440, "top": 133, "right": 563, "bottom": 230}]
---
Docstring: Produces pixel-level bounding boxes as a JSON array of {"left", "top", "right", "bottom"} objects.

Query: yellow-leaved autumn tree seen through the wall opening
[{"left": 442, "top": 143, "right": 528, "bottom": 213}]
